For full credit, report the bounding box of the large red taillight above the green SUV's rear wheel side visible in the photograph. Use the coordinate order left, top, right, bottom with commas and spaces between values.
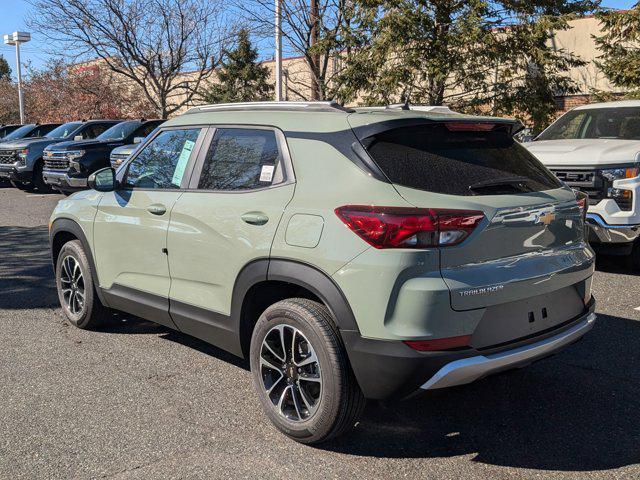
336, 205, 484, 248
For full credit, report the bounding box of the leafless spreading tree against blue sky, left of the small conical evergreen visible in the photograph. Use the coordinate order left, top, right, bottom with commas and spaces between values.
28, 0, 231, 118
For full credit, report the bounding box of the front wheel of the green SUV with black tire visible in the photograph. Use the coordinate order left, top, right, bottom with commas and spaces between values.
56, 240, 111, 329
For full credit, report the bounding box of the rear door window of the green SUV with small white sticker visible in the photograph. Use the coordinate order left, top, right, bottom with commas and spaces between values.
198, 128, 279, 190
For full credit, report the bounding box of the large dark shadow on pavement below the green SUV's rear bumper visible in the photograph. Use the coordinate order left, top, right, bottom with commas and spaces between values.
324, 314, 640, 471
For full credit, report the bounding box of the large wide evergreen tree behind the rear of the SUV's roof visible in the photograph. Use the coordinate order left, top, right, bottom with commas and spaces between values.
333, 0, 599, 129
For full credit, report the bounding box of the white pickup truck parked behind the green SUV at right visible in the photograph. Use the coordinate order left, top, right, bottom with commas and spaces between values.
523, 100, 640, 268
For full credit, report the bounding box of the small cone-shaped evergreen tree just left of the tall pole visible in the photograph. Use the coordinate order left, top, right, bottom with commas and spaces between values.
201, 29, 273, 103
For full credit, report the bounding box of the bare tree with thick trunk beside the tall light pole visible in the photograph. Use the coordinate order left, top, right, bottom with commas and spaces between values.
236, 0, 353, 100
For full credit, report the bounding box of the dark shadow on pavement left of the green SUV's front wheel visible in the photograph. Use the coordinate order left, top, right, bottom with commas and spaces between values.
0, 225, 58, 309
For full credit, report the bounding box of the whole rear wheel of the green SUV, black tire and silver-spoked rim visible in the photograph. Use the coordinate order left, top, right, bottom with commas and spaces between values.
250, 298, 365, 444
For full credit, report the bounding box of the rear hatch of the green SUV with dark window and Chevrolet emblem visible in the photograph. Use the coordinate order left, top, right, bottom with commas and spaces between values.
354, 120, 593, 316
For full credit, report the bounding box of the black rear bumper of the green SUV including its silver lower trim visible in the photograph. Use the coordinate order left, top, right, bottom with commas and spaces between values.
341, 298, 596, 400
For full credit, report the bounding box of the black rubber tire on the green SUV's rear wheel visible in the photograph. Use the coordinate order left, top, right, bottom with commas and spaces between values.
250, 298, 366, 444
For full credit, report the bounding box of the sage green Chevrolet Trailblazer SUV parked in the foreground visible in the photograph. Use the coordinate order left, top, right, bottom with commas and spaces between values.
50, 102, 595, 443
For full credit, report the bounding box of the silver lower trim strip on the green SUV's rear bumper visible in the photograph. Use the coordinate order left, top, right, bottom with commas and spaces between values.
420, 313, 596, 390
